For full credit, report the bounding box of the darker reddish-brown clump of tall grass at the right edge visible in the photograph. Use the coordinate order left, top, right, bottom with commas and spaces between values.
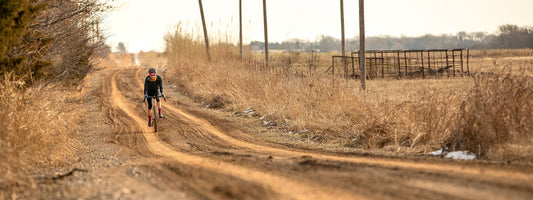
450, 70, 533, 159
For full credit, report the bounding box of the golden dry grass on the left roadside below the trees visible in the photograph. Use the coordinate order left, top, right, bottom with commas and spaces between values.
0, 75, 80, 191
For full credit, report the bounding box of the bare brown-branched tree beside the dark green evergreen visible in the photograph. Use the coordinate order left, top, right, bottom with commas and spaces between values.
30, 0, 113, 84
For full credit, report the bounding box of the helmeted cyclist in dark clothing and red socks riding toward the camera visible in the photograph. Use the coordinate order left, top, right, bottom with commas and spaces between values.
144, 68, 165, 127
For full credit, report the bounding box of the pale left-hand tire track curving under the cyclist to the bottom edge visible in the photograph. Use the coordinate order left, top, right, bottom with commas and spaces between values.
110, 67, 365, 199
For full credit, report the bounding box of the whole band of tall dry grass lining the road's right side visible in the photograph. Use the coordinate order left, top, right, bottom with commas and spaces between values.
162, 27, 533, 158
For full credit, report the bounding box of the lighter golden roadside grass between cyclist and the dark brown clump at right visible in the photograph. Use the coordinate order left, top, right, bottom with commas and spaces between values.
166, 57, 471, 148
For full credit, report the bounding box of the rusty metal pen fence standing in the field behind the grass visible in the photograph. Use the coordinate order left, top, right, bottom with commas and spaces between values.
327, 49, 470, 79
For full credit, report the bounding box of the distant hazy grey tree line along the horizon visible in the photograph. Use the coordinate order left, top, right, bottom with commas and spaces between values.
249, 24, 533, 52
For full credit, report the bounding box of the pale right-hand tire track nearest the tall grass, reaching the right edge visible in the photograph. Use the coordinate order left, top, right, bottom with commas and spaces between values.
131, 69, 533, 183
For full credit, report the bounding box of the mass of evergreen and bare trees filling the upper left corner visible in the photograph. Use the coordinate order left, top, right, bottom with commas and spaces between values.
0, 0, 113, 84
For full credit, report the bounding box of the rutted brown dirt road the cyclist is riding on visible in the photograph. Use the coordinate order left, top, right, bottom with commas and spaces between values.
11, 64, 533, 199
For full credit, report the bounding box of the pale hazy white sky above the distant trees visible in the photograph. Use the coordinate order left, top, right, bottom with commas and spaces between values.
104, 0, 533, 52
